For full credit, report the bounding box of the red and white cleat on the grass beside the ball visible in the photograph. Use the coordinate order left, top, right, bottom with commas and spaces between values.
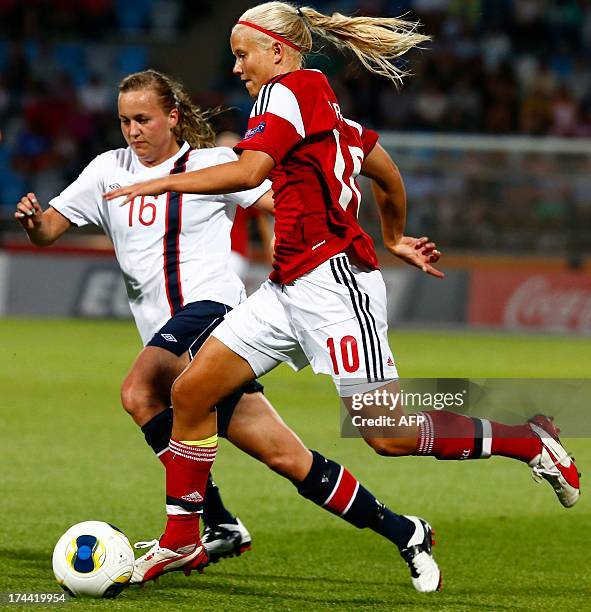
129, 540, 207, 584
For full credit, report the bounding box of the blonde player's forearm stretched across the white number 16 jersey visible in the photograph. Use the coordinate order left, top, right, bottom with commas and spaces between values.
103, 151, 275, 205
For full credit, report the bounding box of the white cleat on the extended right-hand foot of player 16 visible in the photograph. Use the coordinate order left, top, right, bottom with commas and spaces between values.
400, 516, 442, 593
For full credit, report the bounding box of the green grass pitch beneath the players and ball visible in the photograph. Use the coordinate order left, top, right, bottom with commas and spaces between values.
0, 320, 591, 612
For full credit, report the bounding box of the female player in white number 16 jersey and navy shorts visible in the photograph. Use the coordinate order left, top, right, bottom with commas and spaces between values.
15, 71, 454, 592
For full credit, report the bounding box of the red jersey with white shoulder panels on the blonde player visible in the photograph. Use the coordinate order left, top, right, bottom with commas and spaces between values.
235, 70, 378, 284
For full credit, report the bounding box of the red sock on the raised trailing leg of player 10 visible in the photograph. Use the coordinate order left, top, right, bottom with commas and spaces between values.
415, 410, 541, 462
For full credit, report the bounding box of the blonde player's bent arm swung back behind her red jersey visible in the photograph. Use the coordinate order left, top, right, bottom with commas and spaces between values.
361, 143, 444, 278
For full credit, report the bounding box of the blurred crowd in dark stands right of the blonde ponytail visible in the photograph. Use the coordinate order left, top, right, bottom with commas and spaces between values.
332, 0, 591, 137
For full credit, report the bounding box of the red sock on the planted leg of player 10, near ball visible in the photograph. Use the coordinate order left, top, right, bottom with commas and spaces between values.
160, 434, 217, 550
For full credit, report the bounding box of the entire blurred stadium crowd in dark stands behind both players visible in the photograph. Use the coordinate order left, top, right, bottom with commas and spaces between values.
0, 0, 591, 253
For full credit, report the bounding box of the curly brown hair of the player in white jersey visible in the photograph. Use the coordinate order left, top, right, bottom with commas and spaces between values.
119, 69, 217, 149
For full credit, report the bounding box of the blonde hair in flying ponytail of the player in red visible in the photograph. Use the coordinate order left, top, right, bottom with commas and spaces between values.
235, 2, 430, 85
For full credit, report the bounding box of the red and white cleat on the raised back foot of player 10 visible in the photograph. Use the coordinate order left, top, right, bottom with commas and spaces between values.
529, 414, 581, 508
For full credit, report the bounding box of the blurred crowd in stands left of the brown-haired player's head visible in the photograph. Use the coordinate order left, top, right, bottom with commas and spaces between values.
0, 0, 208, 210
